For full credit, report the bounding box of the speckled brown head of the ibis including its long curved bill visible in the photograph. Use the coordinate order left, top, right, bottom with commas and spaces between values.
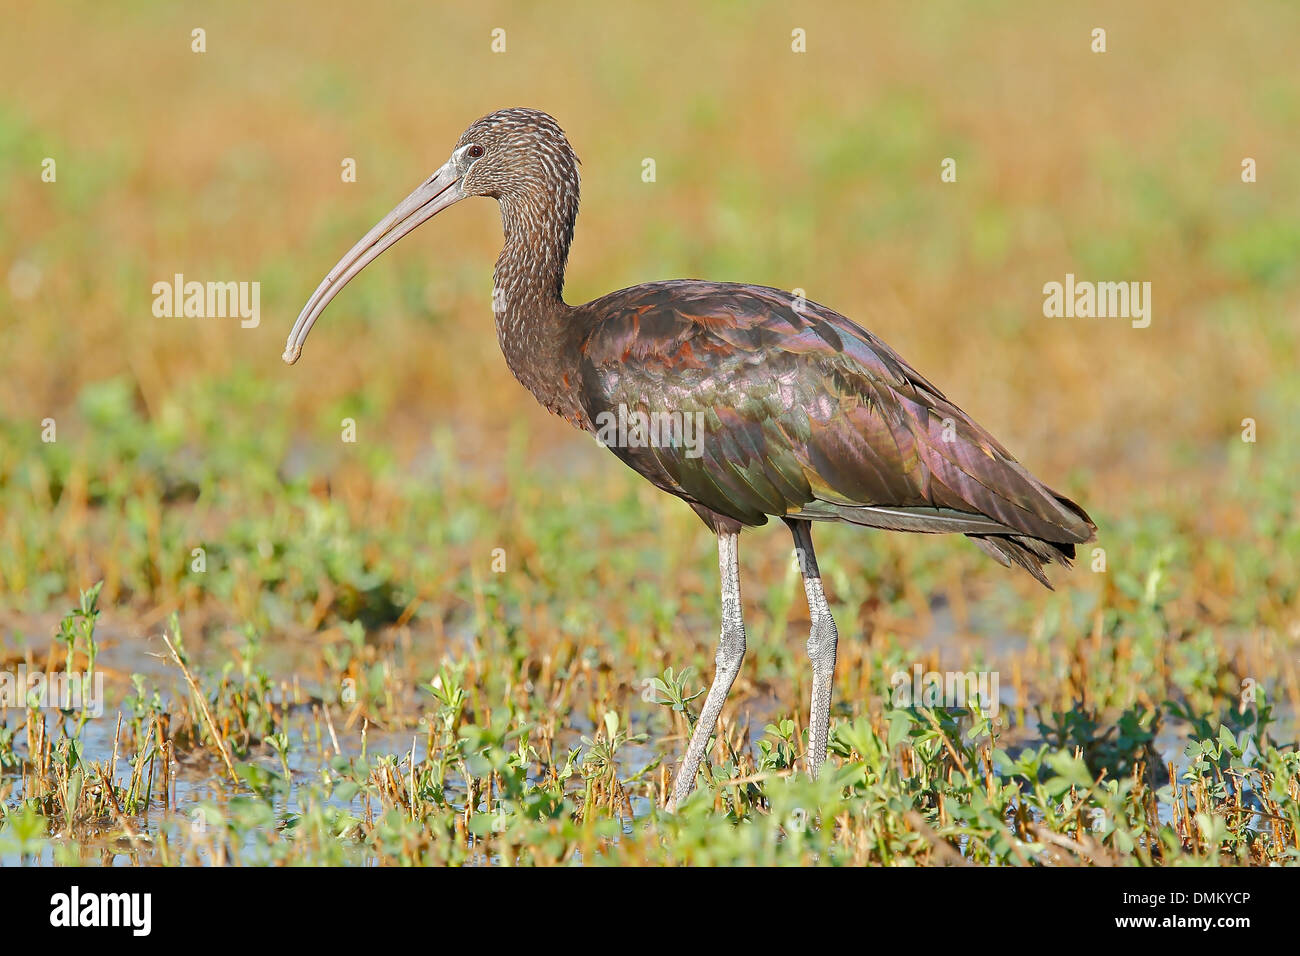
283, 109, 579, 365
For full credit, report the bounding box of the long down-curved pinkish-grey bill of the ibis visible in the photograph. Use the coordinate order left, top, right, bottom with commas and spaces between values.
282, 161, 464, 365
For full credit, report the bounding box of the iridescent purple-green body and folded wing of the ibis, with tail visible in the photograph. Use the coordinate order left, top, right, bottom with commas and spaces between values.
575, 280, 1095, 584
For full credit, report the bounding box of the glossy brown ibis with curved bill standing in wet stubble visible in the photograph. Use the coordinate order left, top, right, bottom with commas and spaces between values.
282, 108, 1096, 812
